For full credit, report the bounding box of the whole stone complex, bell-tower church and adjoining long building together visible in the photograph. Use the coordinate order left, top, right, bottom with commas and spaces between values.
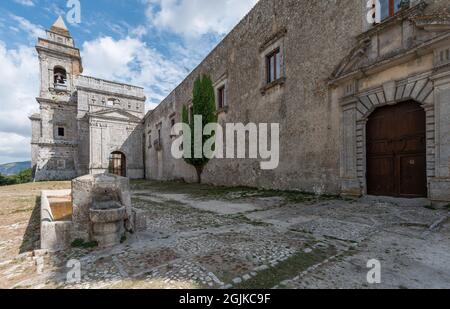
31, 0, 450, 202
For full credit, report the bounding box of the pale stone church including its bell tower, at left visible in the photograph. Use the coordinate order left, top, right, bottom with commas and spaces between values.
30, 17, 146, 180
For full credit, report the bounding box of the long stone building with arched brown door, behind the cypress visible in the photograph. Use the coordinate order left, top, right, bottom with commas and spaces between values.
144, 0, 450, 201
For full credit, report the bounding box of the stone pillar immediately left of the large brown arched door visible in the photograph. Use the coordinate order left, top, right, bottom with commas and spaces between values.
341, 97, 362, 197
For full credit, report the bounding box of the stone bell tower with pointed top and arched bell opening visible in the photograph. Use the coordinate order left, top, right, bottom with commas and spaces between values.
30, 17, 83, 181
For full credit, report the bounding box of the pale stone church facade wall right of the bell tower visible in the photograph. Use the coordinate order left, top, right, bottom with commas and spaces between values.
76, 76, 145, 179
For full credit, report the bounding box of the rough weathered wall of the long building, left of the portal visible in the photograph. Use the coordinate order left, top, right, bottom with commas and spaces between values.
145, 0, 448, 197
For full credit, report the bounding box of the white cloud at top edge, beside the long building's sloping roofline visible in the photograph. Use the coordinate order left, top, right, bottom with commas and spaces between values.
147, 0, 258, 37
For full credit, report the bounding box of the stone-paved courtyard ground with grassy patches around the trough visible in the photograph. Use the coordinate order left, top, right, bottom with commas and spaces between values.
0, 181, 450, 288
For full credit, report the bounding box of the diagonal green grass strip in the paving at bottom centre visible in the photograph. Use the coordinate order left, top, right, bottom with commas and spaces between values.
234, 247, 336, 289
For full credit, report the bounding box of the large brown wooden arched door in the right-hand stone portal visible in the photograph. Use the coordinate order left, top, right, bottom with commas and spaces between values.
366, 101, 427, 198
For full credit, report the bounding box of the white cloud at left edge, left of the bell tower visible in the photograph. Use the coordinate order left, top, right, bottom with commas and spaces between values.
0, 41, 39, 162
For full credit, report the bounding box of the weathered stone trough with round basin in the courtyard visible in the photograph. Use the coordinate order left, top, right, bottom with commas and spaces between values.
41, 174, 146, 250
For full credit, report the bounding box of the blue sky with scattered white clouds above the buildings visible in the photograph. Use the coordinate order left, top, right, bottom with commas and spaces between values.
0, 0, 258, 164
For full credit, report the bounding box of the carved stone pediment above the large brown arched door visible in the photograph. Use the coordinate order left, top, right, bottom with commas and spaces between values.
330, 1, 450, 83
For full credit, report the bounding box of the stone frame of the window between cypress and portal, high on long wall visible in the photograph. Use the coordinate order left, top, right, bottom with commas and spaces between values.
259, 28, 287, 95
